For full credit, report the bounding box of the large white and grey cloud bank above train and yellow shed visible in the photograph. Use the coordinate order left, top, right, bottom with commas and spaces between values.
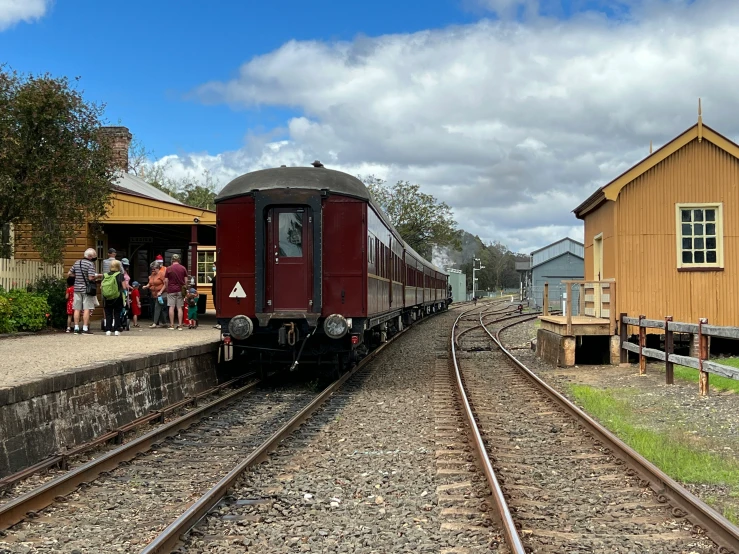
165, 0, 739, 251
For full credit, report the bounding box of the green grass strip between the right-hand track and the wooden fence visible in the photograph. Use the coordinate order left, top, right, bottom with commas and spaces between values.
569, 382, 739, 524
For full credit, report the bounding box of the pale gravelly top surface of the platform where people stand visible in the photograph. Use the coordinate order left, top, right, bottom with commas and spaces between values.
0, 314, 220, 389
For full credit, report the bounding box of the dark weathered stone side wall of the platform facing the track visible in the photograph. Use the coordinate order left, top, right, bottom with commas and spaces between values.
0, 343, 218, 477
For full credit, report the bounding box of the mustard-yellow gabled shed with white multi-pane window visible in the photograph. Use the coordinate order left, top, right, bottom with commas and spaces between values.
574, 114, 739, 326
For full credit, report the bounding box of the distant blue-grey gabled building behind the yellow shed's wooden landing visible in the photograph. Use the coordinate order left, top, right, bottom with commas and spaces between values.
530, 238, 585, 309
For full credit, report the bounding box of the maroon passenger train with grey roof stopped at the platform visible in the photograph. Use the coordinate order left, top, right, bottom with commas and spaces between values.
215, 162, 451, 370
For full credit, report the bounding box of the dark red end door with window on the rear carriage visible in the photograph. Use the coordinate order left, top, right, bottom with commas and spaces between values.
266, 208, 313, 312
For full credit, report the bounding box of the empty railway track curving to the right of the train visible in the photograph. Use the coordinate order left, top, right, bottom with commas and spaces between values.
451, 304, 739, 554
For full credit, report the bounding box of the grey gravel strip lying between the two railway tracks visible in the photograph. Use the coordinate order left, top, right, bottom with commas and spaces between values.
184, 312, 501, 553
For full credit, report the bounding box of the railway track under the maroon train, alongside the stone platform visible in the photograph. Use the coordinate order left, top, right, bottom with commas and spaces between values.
0, 302, 462, 553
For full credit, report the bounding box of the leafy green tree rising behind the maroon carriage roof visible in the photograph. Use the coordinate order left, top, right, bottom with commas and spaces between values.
359, 175, 461, 259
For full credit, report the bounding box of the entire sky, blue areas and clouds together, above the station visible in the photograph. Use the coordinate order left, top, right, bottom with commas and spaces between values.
0, 0, 739, 252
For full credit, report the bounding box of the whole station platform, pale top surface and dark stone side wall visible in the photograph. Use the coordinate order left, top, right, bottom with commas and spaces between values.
0, 314, 220, 478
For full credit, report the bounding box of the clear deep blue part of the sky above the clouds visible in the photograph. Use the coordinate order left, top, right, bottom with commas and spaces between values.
0, 0, 632, 157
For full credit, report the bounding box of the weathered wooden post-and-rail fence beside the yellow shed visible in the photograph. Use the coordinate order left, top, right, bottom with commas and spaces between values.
620, 314, 739, 396
